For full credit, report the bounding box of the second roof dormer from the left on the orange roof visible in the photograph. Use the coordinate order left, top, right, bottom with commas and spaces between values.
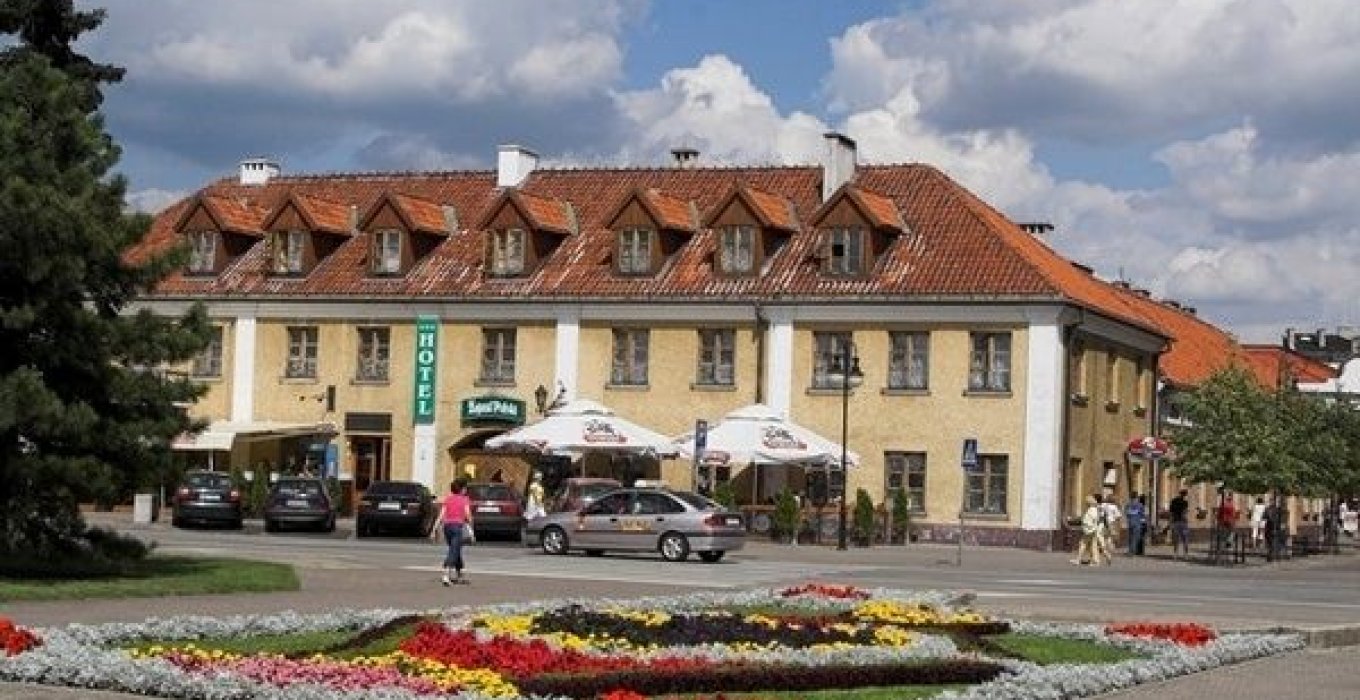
262, 194, 358, 277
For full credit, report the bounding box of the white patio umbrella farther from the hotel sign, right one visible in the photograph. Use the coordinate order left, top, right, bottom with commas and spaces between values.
675, 404, 860, 466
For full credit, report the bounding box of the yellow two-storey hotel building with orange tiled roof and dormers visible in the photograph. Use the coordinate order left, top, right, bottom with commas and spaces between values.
129, 133, 1232, 548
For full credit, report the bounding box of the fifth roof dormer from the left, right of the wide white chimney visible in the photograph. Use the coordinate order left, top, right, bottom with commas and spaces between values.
605, 189, 699, 277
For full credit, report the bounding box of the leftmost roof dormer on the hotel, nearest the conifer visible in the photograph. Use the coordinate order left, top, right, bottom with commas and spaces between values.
174, 194, 264, 276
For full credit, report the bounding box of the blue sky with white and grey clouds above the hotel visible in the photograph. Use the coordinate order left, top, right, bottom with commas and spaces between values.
80, 0, 1360, 343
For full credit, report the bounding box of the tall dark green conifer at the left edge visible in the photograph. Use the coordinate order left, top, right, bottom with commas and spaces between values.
0, 0, 208, 555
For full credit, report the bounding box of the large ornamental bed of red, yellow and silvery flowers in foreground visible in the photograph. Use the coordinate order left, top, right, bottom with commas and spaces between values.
0, 584, 1302, 700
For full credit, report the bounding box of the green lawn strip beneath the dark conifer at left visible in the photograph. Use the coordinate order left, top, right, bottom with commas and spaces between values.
0, 556, 301, 602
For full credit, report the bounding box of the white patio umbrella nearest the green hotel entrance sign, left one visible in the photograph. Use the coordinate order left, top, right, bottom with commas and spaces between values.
487, 398, 679, 457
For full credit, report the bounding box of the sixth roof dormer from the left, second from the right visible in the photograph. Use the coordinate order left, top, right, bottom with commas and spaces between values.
703, 186, 798, 277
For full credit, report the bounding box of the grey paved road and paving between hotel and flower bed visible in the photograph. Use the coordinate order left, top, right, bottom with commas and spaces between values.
0, 515, 1360, 700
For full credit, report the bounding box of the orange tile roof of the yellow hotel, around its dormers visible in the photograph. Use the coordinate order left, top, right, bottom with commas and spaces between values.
138, 164, 1272, 369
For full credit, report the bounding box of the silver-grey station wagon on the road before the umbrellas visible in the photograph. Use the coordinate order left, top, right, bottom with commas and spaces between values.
525, 488, 747, 564
